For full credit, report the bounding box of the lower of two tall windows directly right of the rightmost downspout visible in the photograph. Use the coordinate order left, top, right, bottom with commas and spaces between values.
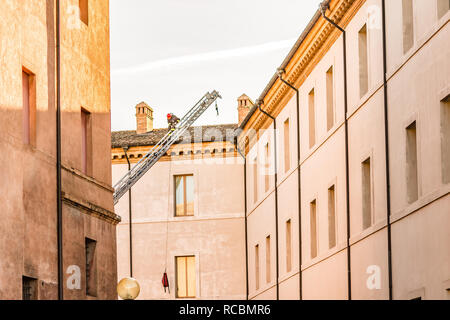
406, 121, 419, 203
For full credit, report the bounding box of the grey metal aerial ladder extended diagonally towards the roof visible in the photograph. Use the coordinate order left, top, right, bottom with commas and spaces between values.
114, 90, 222, 204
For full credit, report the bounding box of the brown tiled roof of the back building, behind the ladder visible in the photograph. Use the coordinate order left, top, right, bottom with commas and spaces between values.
111, 124, 238, 148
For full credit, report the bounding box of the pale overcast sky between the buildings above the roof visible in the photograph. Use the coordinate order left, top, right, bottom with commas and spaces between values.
110, 0, 320, 131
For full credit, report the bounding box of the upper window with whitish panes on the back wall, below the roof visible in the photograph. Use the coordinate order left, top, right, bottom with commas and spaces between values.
175, 175, 194, 217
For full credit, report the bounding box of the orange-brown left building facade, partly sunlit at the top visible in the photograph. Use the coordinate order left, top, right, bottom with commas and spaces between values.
0, 0, 120, 300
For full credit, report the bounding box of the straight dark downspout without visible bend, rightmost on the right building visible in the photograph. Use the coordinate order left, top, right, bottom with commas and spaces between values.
381, 0, 393, 300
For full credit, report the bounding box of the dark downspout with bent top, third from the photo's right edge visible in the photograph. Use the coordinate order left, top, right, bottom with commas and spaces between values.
278, 68, 303, 300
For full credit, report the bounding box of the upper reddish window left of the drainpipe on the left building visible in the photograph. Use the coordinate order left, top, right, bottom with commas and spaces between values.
22, 70, 36, 145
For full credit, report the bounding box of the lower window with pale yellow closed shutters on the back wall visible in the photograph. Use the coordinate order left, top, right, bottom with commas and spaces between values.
176, 256, 196, 298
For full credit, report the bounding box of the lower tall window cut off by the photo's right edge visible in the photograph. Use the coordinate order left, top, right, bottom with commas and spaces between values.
441, 97, 450, 184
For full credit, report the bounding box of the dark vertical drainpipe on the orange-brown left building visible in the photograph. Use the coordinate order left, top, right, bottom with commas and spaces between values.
56, 0, 64, 300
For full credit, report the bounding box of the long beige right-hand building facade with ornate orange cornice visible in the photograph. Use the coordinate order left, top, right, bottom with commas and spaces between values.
239, 0, 450, 300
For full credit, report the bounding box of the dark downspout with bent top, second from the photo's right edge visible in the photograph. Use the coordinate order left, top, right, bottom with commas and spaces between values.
320, 0, 352, 300
